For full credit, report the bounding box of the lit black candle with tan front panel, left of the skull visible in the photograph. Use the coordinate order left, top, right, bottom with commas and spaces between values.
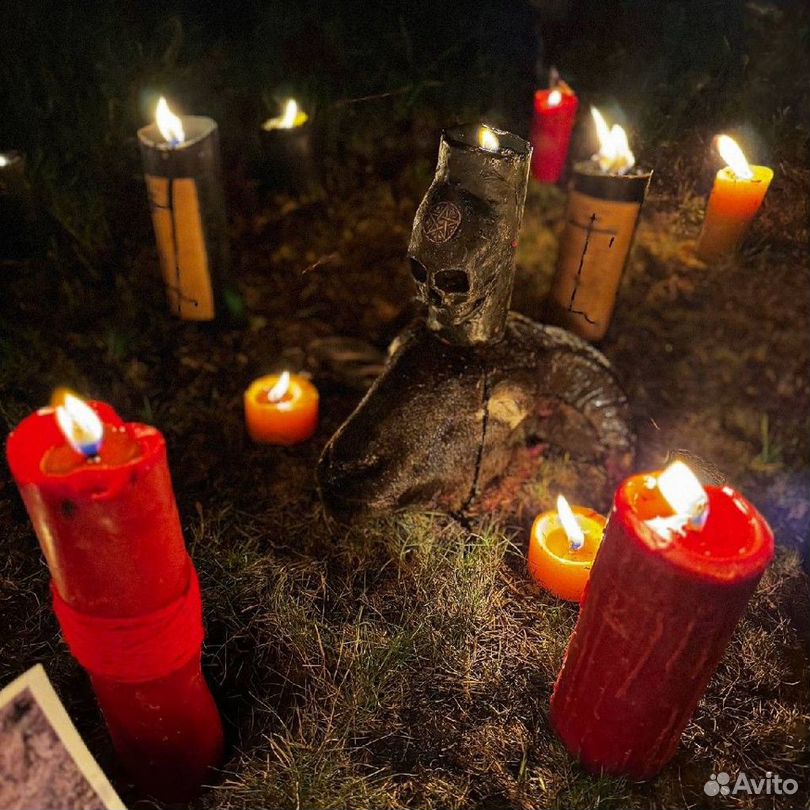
138, 99, 229, 321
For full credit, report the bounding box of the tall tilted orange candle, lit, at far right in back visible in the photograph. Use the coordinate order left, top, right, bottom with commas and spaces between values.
697, 135, 773, 261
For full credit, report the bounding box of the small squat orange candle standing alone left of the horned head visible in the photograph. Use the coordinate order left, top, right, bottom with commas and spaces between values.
245, 371, 318, 445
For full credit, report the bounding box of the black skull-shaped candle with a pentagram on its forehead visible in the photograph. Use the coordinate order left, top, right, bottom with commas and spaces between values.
408, 125, 531, 345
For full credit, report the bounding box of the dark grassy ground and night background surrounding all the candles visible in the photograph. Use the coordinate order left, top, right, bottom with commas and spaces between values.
0, 0, 810, 810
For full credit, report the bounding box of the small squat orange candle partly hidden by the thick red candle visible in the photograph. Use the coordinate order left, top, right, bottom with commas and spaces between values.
529, 495, 605, 602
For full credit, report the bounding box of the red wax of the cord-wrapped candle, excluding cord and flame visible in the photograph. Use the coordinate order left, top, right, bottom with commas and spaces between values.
7, 402, 222, 801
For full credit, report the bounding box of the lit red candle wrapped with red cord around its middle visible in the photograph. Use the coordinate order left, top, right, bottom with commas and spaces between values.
7, 390, 223, 801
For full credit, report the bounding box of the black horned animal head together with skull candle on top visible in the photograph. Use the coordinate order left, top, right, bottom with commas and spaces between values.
318, 127, 634, 517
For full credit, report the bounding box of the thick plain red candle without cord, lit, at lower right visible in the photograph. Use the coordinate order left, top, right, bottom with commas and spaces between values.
551, 462, 773, 779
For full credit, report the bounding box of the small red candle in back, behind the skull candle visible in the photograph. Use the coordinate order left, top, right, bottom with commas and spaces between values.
531, 83, 579, 183
